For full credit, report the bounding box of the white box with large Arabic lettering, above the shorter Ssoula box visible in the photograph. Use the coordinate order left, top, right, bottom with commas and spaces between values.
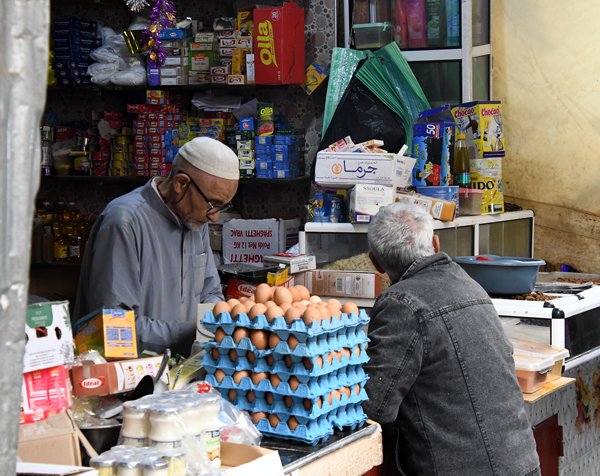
315, 151, 396, 188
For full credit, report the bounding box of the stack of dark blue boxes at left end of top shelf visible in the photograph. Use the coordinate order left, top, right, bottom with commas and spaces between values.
52, 18, 101, 86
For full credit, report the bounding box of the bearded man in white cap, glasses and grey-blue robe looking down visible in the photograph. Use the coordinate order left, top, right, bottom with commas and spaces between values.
75, 137, 239, 355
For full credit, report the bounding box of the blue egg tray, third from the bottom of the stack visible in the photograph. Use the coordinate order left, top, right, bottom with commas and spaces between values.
206, 366, 367, 398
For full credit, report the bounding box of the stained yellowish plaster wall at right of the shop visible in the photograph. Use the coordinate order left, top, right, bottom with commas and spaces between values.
492, 0, 600, 273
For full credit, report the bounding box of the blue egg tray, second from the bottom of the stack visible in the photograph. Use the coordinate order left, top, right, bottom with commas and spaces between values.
219, 380, 369, 424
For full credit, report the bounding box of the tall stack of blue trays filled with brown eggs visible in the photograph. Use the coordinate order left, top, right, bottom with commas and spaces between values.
203, 284, 369, 444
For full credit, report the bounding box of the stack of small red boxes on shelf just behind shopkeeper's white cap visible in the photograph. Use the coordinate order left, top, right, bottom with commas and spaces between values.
127, 90, 184, 176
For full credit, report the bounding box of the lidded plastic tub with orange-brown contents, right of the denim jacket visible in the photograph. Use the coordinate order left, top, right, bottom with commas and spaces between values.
510, 338, 569, 393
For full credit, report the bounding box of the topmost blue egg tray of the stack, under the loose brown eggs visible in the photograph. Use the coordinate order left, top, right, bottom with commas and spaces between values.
203, 309, 369, 340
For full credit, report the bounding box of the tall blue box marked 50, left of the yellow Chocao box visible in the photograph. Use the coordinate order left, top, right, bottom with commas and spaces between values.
412, 106, 455, 186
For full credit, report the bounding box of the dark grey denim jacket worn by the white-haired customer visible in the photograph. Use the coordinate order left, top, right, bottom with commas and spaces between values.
364, 253, 539, 476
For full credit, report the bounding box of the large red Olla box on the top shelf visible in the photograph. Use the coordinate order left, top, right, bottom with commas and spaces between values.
253, 2, 305, 84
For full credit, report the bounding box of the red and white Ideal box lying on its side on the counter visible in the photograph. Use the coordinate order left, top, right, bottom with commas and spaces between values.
70, 356, 168, 397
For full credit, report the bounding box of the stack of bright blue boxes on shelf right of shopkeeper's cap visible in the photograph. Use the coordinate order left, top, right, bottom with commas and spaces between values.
254, 134, 303, 179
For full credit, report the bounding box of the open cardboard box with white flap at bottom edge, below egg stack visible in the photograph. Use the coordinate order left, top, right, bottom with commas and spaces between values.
221, 442, 284, 476
